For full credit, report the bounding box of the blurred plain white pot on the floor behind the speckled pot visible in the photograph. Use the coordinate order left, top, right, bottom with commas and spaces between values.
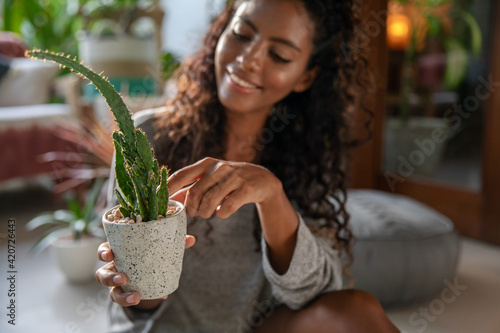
51, 236, 103, 283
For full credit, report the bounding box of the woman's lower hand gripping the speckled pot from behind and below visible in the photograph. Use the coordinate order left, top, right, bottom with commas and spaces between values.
95, 235, 196, 310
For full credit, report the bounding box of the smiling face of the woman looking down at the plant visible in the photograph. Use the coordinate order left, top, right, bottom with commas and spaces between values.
215, 0, 317, 115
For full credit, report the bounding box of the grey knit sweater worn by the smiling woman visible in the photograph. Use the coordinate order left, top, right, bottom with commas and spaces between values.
109, 112, 342, 333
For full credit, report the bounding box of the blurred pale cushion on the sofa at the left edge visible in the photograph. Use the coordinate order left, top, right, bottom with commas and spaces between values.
0, 58, 58, 106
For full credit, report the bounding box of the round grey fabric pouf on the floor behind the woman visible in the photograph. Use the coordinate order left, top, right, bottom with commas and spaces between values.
346, 190, 460, 308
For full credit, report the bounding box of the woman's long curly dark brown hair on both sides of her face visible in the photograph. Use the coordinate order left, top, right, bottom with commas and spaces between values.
154, 0, 372, 278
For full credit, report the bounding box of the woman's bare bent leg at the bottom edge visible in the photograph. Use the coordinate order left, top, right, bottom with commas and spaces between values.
254, 290, 399, 333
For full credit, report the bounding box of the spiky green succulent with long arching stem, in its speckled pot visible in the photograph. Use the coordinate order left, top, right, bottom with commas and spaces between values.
27, 49, 187, 299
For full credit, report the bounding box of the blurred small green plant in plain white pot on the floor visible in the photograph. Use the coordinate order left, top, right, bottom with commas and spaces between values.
26, 178, 104, 283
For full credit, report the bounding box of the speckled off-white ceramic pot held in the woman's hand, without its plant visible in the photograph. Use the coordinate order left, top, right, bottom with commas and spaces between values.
102, 200, 187, 299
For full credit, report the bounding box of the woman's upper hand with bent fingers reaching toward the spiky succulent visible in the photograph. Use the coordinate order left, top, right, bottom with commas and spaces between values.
168, 157, 283, 219
